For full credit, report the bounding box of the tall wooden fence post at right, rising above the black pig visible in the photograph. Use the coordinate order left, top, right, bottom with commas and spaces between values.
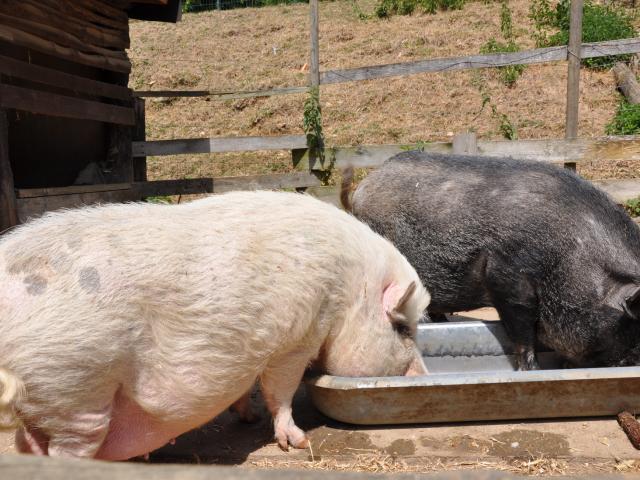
565, 0, 583, 140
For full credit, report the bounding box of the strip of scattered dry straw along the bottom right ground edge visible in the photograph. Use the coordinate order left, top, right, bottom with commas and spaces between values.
247, 455, 640, 477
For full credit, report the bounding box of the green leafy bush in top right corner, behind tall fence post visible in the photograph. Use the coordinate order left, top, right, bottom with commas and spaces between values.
529, 0, 636, 69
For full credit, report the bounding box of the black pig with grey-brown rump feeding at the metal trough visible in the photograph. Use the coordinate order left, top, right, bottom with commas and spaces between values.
341, 152, 640, 370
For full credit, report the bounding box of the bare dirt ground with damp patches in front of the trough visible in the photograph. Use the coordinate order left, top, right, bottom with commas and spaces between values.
5, 382, 640, 475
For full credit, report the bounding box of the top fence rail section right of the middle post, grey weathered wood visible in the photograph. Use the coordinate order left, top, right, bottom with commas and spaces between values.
320, 38, 640, 85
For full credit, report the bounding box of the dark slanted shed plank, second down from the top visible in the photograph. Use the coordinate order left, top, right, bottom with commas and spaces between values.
0, 24, 131, 73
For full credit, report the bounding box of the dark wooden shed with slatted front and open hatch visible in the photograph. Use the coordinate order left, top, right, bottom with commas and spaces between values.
0, 0, 181, 231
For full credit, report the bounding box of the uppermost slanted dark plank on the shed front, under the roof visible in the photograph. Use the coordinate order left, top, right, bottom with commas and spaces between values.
0, 0, 130, 50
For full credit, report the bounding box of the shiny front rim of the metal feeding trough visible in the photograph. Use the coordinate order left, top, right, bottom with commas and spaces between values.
305, 367, 640, 390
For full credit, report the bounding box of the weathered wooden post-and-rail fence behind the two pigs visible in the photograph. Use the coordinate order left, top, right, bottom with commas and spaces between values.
13, 0, 640, 220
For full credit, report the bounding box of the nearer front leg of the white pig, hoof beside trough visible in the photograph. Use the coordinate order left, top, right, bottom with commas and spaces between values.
260, 350, 310, 451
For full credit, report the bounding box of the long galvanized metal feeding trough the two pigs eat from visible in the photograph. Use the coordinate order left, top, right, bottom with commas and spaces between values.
306, 321, 640, 425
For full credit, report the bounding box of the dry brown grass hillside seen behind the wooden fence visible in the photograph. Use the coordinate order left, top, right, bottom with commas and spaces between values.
130, 0, 640, 182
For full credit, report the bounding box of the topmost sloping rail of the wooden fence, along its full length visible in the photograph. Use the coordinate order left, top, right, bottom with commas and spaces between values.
134, 38, 640, 100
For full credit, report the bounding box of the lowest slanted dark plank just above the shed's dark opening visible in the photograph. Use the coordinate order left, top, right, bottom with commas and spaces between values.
0, 85, 135, 125
